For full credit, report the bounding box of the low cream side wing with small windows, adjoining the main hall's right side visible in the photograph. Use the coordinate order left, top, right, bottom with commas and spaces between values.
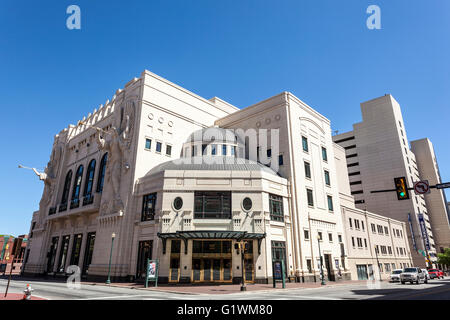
334, 144, 413, 280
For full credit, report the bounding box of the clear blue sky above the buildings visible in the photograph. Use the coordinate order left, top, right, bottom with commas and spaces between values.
0, 0, 450, 235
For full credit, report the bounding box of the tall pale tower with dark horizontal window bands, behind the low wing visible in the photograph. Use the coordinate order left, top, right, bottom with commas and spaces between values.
333, 95, 436, 267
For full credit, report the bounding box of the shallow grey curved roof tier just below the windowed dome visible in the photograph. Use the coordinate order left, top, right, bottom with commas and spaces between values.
146, 156, 279, 176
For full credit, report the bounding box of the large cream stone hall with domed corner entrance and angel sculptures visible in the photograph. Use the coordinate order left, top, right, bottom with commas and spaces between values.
25, 71, 416, 283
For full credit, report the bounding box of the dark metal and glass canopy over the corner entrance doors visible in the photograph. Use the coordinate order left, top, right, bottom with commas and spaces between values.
157, 230, 266, 254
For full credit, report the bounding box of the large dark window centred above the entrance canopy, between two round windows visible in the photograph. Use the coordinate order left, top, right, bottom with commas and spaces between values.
194, 191, 231, 219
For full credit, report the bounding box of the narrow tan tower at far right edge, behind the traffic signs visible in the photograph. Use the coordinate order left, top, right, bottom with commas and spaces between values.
411, 138, 450, 252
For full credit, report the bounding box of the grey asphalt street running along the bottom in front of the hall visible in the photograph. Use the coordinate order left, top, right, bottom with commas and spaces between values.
0, 278, 450, 300
